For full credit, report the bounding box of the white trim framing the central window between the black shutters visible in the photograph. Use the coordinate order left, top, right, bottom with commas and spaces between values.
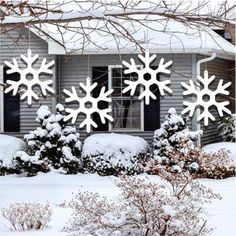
108, 65, 144, 132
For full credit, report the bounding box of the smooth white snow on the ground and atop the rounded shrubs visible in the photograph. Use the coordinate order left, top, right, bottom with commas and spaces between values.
0, 137, 236, 236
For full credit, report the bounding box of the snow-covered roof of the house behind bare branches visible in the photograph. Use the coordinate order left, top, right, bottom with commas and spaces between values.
0, 4, 236, 60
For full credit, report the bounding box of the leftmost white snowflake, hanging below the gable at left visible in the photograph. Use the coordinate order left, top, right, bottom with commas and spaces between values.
5, 49, 54, 105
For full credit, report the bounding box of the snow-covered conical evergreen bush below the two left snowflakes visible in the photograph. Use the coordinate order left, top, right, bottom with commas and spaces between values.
13, 104, 81, 176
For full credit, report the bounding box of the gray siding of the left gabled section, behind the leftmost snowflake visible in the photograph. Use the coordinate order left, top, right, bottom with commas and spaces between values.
0, 29, 54, 137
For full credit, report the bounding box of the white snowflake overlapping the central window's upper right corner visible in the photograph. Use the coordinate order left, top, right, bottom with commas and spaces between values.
122, 50, 172, 105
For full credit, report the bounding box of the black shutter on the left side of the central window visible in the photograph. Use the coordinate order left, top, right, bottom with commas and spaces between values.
92, 67, 109, 131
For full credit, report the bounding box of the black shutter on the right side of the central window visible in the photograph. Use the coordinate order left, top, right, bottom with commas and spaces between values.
144, 67, 160, 131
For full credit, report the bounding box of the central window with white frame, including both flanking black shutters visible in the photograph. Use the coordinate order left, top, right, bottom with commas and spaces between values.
92, 66, 160, 132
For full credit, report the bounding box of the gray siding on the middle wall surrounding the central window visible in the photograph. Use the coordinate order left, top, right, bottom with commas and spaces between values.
58, 54, 192, 142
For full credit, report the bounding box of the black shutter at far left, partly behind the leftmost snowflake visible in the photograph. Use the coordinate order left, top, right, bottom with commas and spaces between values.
3, 67, 20, 132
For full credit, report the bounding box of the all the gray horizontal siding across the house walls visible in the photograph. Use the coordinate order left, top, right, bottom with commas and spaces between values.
0, 26, 231, 145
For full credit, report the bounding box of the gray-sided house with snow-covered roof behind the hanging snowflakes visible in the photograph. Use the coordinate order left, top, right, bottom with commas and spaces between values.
0, 12, 235, 144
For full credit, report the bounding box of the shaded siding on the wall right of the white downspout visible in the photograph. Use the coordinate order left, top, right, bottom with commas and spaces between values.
199, 58, 232, 146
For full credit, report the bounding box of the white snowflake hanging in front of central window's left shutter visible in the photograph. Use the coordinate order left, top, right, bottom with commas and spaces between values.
63, 77, 113, 133
